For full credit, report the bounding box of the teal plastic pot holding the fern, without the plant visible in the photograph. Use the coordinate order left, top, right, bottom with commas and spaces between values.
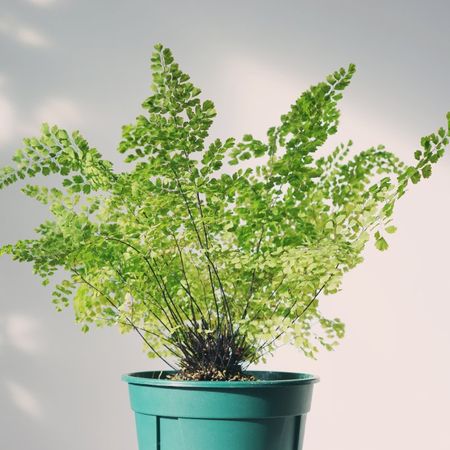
122, 371, 319, 450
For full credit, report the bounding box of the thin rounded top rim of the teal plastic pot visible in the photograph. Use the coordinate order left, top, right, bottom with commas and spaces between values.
122, 370, 320, 389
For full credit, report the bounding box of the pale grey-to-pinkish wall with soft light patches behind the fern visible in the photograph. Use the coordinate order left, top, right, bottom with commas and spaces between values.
0, 0, 450, 450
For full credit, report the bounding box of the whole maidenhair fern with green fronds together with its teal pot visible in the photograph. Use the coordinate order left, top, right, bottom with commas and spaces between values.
0, 45, 450, 450
